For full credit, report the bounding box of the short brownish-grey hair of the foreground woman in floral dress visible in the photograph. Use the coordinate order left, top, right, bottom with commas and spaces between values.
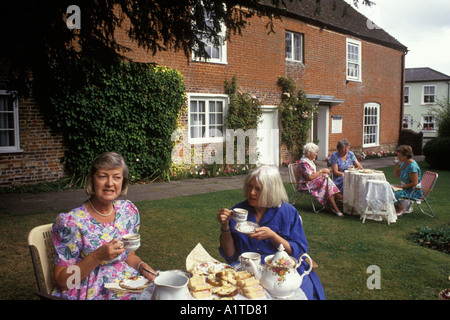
84, 152, 129, 196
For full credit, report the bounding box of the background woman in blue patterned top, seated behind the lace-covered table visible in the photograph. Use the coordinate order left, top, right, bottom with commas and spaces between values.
328, 139, 363, 193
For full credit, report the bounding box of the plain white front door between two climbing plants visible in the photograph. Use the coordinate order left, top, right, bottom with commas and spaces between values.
257, 106, 280, 166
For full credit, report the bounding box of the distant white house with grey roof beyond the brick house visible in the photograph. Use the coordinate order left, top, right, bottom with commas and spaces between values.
403, 68, 450, 140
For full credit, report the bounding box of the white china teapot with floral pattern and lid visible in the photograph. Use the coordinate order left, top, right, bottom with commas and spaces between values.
249, 244, 313, 299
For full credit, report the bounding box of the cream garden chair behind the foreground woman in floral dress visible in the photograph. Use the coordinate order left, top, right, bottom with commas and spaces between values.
28, 223, 64, 300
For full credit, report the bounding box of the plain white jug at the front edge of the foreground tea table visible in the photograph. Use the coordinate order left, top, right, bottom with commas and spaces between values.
151, 271, 191, 300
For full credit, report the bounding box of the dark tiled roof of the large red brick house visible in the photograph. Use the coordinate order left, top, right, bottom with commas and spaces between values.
262, 0, 407, 52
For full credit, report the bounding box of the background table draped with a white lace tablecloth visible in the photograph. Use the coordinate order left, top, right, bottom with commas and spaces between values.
343, 170, 397, 223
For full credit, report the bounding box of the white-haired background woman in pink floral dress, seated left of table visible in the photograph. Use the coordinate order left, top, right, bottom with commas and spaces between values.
297, 142, 344, 217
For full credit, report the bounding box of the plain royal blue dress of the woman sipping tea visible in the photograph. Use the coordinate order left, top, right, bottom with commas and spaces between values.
219, 200, 325, 300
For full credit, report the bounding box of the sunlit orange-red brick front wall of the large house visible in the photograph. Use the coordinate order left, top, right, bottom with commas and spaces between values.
120, 14, 403, 161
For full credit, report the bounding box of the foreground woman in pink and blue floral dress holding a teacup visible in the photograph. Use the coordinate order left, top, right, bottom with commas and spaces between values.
52, 152, 158, 300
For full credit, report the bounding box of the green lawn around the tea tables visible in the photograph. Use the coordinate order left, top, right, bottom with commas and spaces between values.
0, 163, 450, 300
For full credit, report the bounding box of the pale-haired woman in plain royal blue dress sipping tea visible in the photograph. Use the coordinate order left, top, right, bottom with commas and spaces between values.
217, 166, 325, 300
